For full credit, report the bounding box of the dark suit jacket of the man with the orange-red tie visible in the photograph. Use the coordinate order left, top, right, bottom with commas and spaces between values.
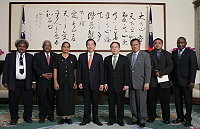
77, 52, 104, 90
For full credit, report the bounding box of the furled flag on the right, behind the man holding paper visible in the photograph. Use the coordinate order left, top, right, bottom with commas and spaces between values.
148, 7, 153, 51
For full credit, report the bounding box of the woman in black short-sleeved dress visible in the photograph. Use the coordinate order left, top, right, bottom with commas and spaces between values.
53, 42, 77, 124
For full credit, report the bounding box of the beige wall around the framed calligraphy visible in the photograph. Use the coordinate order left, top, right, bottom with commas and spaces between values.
0, 0, 194, 60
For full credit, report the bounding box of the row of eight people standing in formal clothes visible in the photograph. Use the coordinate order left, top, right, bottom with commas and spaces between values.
2, 37, 197, 127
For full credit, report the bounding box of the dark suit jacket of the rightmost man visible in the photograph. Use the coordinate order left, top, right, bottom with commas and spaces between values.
172, 48, 198, 86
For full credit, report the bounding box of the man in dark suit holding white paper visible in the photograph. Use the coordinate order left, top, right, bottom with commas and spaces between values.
147, 38, 173, 124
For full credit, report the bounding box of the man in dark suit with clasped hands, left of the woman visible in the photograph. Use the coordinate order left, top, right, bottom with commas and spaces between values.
33, 40, 55, 123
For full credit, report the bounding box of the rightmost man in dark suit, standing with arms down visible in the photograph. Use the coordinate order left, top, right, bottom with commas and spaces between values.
172, 37, 197, 127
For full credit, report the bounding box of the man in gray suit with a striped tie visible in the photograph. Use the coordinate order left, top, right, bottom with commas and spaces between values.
127, 39, 151, 127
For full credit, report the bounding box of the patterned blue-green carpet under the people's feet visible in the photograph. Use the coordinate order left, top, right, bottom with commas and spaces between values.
0, 104, 200, 129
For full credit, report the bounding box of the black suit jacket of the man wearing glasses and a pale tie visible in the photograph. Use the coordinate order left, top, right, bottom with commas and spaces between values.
104, 54, 130, 92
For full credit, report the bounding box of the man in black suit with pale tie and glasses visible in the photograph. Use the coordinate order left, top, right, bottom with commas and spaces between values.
104, 42, 130, 126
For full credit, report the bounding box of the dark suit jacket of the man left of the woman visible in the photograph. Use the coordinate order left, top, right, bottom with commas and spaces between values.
33, 52, 56, 85
